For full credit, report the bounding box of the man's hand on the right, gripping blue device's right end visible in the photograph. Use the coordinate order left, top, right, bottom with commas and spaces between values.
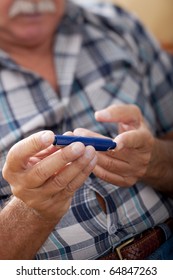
74, 105, 154, 187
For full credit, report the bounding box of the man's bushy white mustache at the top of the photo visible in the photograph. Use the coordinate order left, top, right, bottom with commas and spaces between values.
9, 0, 56, 18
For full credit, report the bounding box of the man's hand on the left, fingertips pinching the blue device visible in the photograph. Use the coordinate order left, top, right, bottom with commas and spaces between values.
3, 131, 97, 222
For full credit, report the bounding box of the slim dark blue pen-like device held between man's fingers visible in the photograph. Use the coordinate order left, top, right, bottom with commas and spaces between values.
53, 135, 116, 151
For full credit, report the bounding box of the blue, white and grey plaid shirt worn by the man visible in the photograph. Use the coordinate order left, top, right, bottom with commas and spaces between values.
0, 0, 173, 259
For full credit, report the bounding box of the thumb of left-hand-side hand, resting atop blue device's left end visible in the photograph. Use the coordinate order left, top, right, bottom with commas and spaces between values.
4, 131, 54, 172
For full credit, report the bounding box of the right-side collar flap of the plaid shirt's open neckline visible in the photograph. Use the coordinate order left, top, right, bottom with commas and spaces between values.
54, 1, 83, 97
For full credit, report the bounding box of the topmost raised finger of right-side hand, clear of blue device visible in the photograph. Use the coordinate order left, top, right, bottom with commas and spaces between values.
95, 104, 142, 127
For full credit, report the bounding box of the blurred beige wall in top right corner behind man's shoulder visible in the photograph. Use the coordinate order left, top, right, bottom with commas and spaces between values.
105, 0, 173, 50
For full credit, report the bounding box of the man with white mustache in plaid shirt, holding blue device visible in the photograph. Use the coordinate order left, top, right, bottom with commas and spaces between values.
0, 0, 173, 260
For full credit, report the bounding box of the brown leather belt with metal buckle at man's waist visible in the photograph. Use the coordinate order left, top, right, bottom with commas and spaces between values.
99, 218, 173, 260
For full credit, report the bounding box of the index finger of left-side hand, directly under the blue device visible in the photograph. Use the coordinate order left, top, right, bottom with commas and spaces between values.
26, 142, 85, 187
